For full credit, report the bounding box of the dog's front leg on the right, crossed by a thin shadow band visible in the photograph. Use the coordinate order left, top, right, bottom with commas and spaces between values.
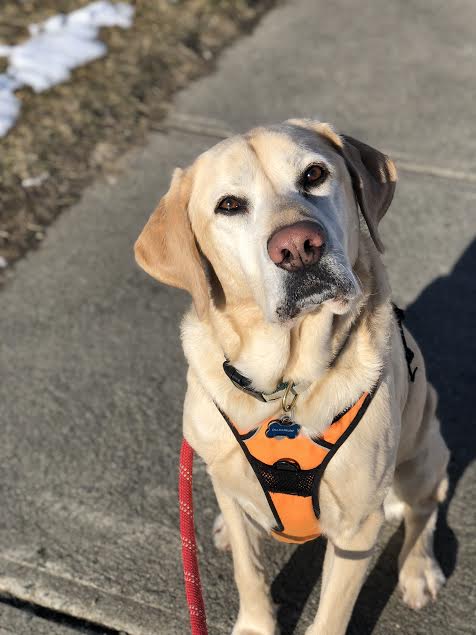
306, 511, 383, 635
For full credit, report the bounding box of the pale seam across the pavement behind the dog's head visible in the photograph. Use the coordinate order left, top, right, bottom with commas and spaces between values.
164, 113, 476, 185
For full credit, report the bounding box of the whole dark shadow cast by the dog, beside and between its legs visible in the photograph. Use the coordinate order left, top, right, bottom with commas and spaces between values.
271, 240, 476, 635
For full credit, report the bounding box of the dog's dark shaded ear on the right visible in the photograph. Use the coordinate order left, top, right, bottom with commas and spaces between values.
340, 135, 397, 253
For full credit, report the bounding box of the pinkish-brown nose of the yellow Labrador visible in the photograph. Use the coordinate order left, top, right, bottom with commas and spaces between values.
268, 221, 324, 271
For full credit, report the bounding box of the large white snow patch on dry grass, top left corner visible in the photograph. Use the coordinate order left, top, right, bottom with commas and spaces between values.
0, 0, 134, 137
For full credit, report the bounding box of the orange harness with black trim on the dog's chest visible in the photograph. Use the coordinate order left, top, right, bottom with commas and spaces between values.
219, 390, 375, 543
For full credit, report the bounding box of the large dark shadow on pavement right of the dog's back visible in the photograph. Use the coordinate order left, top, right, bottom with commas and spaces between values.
407, 240, 476, 576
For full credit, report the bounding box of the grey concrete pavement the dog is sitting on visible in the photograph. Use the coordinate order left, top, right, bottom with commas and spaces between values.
0, 0, 476, 635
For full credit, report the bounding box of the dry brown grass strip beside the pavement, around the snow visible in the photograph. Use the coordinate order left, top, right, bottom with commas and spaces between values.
0, 0, 273, 270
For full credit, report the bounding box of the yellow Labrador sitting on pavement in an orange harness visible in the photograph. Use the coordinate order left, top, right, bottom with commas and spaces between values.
135, 119, 449, 635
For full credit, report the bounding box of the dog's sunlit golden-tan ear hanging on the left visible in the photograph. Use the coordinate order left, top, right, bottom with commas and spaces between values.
134, 168, 209, 319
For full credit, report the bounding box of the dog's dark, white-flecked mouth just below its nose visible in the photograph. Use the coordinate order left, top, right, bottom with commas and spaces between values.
276, 256, 358, 322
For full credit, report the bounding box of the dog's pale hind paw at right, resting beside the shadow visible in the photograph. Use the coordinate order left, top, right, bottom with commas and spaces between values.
399, 556, 446, 610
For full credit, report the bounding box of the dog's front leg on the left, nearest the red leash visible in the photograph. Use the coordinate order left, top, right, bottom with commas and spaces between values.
213, 480, 275, 635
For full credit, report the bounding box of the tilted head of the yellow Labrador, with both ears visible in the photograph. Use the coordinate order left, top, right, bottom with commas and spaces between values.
135, 120, 396, 322
